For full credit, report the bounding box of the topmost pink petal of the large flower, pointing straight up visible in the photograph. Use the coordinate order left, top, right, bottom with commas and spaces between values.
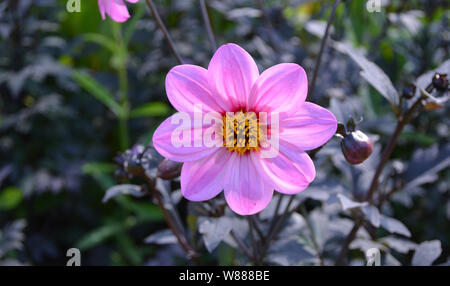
208, 44, 259, 112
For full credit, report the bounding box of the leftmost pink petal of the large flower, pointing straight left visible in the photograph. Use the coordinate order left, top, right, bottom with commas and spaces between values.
152, 113, 219, 162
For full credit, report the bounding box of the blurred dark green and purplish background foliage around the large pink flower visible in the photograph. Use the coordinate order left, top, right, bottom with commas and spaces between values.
0, 0, 450, 265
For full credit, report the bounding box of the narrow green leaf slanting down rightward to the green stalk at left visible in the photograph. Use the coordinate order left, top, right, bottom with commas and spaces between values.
72, 71, 123, 117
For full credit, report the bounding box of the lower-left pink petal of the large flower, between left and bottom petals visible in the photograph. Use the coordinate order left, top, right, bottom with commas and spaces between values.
181, 148, 235, 201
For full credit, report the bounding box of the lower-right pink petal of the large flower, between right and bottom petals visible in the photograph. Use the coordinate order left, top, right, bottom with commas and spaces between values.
253, 145, 316, 194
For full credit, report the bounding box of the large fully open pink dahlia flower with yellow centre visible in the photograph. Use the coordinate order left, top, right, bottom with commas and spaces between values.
153, 44, 337, 215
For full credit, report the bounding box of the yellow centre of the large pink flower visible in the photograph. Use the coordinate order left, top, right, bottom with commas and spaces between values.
223, 111, 259, 155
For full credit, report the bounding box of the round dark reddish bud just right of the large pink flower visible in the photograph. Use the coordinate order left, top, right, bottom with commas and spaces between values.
341, 130, 373, 165
